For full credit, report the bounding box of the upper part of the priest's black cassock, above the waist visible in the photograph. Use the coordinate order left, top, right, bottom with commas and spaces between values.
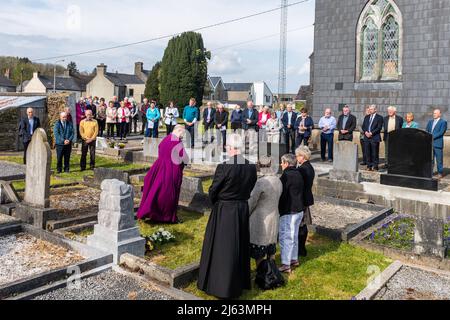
209, 156, 258, 205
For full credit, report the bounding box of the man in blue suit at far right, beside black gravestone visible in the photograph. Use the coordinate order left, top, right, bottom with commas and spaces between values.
427, 109, 448, 179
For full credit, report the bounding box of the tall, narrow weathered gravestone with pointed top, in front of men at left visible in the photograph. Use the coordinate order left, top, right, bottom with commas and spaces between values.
14, 128, 57, 229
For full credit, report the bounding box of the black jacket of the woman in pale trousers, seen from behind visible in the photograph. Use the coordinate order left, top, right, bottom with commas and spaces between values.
278, 167, 305, 216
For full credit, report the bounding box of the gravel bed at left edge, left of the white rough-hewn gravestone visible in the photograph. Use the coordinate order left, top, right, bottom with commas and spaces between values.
0, 233, 85, 285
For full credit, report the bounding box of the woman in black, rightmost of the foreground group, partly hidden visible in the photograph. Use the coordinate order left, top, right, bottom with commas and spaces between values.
295, 146, 316, 257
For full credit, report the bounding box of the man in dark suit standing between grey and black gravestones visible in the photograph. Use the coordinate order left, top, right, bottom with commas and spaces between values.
362, 105, 383, 171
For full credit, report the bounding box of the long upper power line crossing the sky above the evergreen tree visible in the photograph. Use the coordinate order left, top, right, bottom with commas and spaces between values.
32, 0, 310, 62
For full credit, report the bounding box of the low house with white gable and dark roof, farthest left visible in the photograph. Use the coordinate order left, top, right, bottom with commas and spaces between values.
22, 71, 92, 99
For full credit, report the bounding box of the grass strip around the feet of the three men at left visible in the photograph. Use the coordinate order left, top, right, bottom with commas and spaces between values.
0, 153, 148, 186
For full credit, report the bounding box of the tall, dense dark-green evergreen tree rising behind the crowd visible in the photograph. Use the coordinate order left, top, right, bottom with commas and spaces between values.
160, 32, 211, 107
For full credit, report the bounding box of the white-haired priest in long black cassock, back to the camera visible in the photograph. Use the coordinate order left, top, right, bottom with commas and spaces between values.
197, 134, 257, 299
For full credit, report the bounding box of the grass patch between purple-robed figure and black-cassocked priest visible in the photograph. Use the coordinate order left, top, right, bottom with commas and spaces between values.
138, 211, 208, 269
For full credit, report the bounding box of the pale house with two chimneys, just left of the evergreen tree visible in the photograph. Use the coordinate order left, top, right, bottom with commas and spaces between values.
86, 63, 149, 103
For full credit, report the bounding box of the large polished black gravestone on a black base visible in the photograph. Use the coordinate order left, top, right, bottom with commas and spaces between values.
381, 129, 438, 191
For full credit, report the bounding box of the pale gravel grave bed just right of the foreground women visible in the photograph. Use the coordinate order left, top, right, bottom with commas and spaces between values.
311, 201, 376, 230
